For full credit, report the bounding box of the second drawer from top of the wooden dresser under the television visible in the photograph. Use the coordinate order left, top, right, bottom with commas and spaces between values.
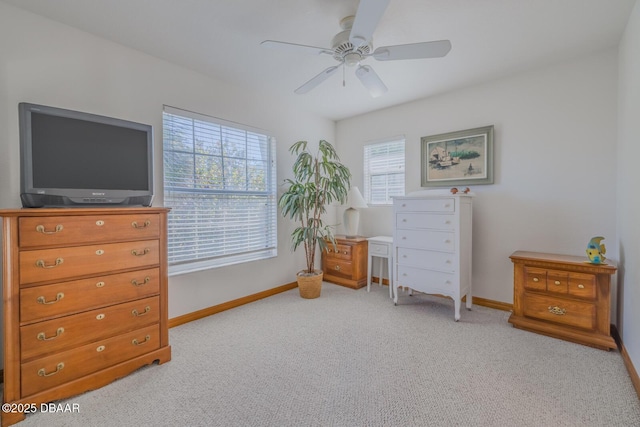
20, 240, 160, 284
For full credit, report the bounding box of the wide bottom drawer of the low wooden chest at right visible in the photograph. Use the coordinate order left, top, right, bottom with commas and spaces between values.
524, 293, 596, 330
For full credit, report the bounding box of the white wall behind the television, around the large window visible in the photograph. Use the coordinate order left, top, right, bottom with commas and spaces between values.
0, 2, 335, 366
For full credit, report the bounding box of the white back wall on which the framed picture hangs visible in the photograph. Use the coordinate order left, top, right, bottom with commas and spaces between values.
337, 49, 617, 303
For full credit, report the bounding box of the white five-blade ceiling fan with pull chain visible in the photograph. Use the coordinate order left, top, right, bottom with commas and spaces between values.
261, 0, 451, 98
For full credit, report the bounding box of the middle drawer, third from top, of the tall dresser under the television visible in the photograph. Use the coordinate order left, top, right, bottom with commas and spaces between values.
20, 268, 160, 325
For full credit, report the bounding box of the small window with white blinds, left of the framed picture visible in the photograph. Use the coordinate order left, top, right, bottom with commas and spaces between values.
364, 137, 404, 205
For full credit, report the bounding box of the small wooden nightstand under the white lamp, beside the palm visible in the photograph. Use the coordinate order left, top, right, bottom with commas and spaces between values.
322, 236, 368, 289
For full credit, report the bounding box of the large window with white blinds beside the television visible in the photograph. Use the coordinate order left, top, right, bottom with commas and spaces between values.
162, 106, 277, 274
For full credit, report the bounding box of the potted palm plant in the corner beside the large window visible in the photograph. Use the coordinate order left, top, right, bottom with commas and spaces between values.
278, 140, 351, 298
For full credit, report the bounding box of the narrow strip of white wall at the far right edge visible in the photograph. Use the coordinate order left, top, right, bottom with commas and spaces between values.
617, 2, 640, 380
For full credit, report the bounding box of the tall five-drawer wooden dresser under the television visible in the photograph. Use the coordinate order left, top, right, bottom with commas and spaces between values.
0, 208, 171, 426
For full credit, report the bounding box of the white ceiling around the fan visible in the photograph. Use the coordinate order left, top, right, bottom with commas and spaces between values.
2, 0, 636, 120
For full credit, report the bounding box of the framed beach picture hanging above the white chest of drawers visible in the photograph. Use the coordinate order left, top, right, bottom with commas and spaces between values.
420, 125, 493, 187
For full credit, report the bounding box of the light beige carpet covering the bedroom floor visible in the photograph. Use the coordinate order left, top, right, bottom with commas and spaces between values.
15, 283, 640, 427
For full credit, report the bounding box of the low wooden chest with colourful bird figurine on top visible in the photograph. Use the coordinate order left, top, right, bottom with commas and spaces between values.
509, 251, 617, 350
